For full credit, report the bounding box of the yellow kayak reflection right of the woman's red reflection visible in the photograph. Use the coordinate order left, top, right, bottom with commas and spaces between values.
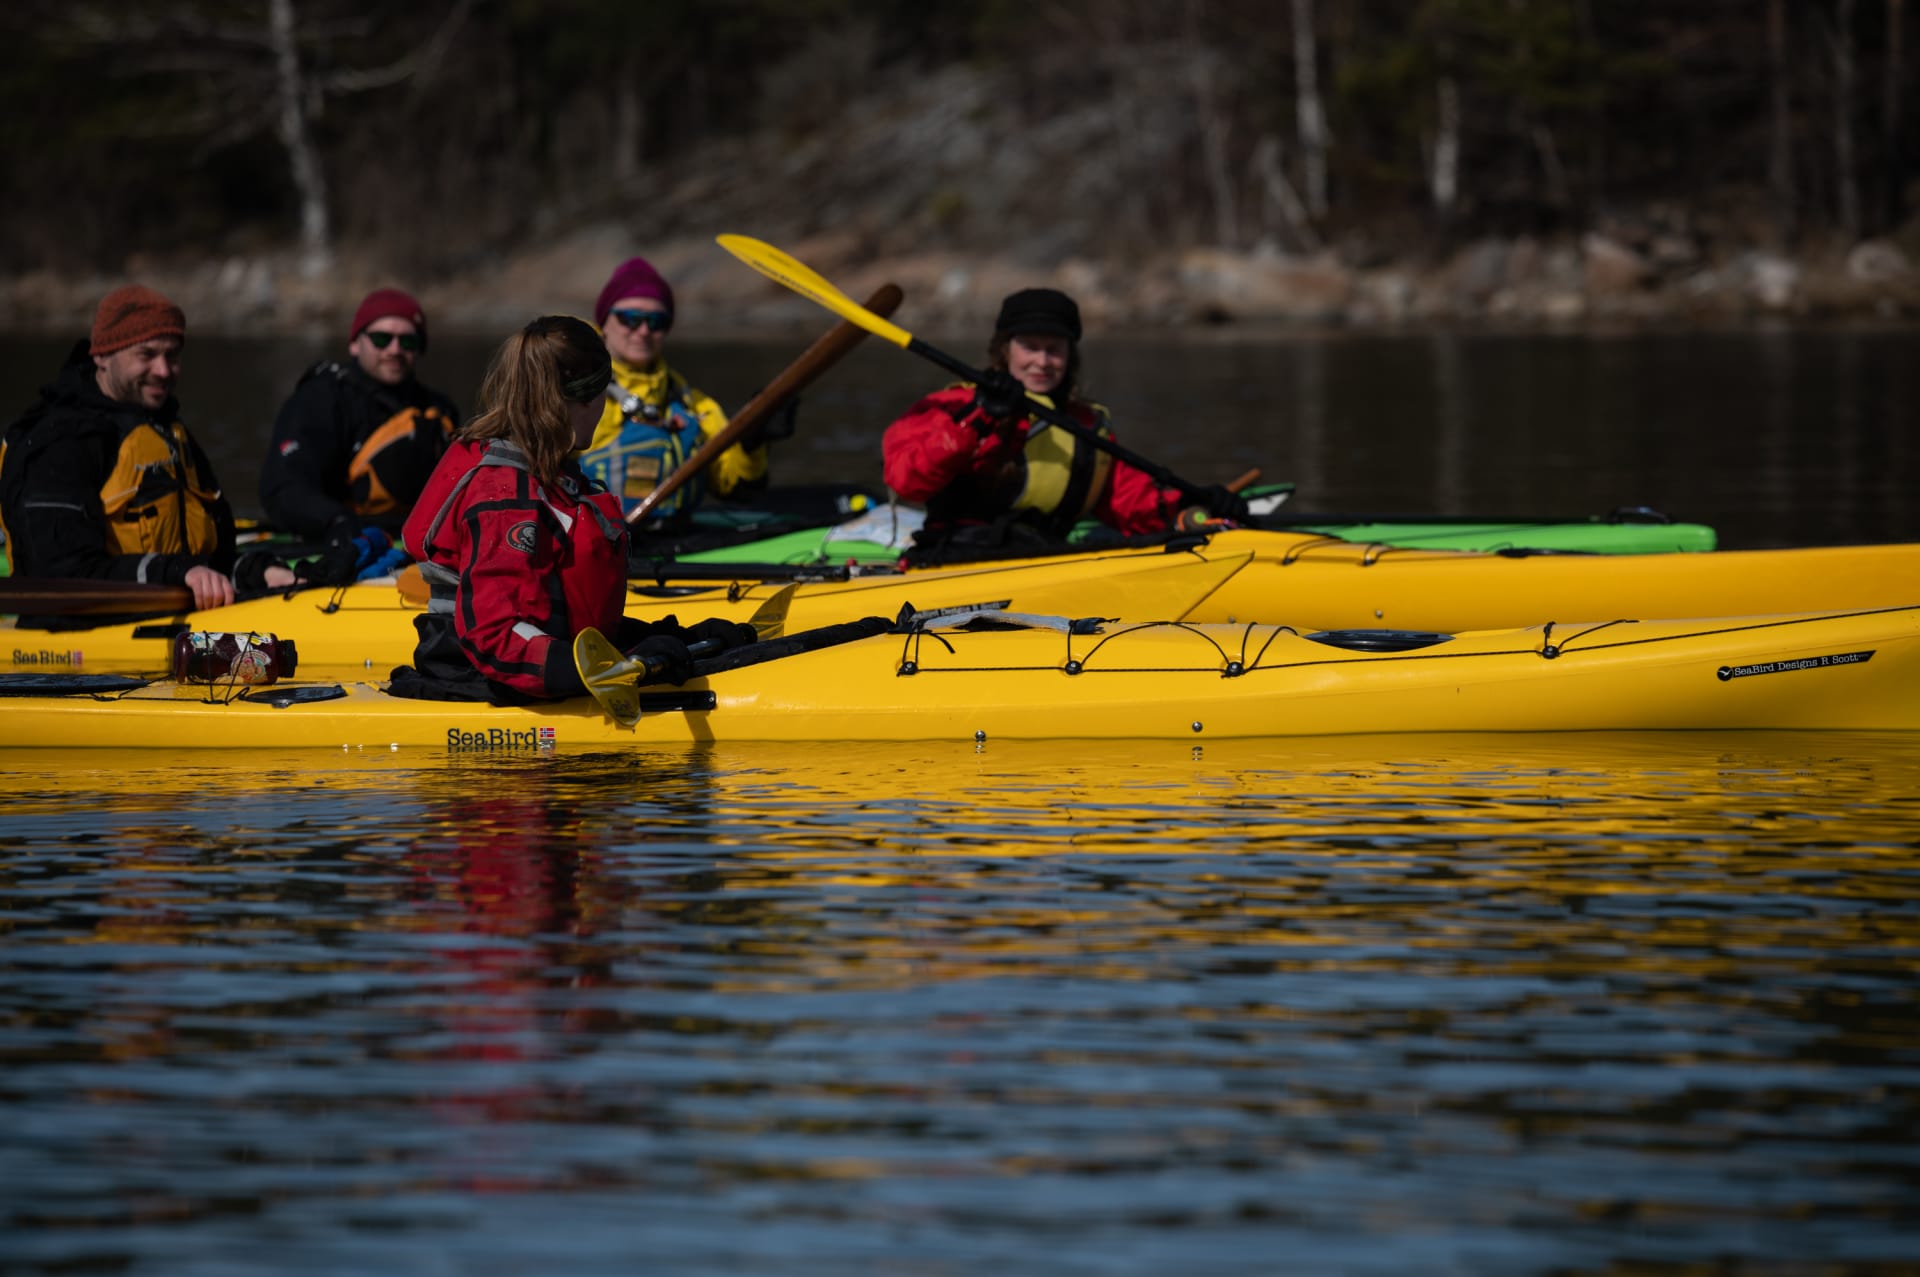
648, 734, 1920, 989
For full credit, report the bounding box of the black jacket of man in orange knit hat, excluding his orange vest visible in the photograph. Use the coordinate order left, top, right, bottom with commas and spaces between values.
0, 342, 234, 586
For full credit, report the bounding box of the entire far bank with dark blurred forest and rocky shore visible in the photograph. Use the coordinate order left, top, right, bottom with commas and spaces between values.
0, 0, 1920, 328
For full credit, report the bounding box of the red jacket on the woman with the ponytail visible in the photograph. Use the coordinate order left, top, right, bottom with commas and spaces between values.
396, 440, 626, 703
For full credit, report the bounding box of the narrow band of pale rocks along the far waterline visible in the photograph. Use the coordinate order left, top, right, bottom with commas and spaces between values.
0, 225, 1920, 336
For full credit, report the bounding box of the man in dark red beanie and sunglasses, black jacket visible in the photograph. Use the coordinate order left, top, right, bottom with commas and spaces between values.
259, 288, 459, 582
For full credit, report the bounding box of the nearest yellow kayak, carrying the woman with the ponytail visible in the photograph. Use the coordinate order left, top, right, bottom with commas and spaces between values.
0, 607, 1920, 753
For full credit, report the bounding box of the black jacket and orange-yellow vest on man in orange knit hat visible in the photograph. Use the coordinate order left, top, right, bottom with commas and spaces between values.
0, 342, 234, 586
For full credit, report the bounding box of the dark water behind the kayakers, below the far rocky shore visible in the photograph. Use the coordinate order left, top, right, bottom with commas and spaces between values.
0, 328, 1920, 547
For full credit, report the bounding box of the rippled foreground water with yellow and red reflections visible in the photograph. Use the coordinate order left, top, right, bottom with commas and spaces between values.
0, 734, 1920, 1275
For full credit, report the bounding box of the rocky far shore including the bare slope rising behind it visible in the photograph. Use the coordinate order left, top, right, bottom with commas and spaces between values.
0, 50, 1920, 336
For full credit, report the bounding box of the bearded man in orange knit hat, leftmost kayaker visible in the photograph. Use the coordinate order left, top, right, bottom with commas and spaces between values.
0, 284, 296, 624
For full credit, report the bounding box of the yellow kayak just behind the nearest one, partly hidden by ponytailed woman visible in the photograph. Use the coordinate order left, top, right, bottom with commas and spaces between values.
0, 530, 1920, 676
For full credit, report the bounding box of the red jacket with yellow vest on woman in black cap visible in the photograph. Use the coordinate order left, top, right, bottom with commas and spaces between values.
881, 384, 1171, 538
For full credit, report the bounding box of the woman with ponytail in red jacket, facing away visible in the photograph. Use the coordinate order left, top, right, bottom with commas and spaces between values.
392, 315, 753, 703
